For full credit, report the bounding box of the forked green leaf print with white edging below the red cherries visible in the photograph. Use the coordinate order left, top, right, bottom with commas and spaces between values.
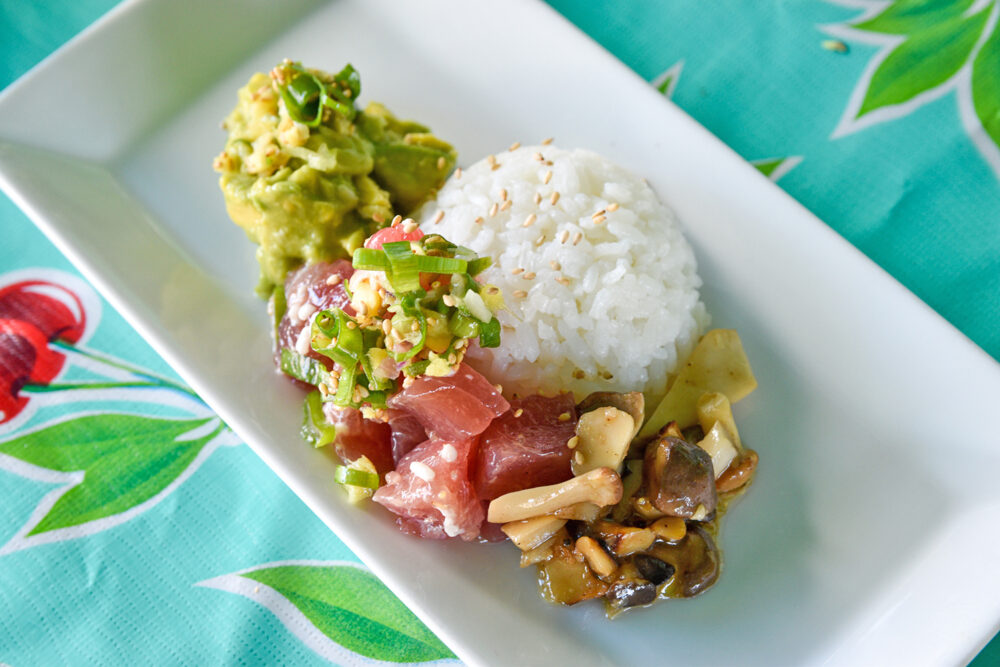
0, 413, 226, 554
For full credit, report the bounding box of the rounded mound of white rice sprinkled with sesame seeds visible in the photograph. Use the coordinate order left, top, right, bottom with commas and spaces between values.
420, 146, 708, 402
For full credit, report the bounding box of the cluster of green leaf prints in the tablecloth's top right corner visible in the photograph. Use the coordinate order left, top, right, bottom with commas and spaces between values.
821, 0, 1000, 177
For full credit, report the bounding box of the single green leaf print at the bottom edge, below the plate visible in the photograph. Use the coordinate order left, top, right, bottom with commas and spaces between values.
197, 561, 455, 663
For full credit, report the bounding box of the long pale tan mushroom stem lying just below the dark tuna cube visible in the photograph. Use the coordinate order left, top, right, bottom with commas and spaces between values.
486, 468, 620, 523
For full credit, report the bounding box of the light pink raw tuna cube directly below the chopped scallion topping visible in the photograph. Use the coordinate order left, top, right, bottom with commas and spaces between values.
389, 364, 510, 442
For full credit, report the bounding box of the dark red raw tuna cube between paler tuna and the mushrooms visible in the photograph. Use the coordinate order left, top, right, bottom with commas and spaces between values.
474, 393, 576, 500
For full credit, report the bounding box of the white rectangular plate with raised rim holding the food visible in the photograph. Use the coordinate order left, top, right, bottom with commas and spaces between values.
0, 0, 1000, 665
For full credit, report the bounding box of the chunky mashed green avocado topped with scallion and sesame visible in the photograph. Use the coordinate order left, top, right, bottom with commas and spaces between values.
213, 61, 455, 296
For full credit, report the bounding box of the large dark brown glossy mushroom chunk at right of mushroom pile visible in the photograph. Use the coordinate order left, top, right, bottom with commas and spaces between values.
642, 436, 718, 520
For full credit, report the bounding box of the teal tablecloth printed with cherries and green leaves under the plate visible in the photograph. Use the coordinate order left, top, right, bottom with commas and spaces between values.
0, 0, 1000, 667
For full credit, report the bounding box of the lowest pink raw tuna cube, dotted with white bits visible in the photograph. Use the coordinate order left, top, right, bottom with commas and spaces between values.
373, 438, 486, 540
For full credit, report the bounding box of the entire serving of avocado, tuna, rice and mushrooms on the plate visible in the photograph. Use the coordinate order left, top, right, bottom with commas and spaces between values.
214, 61, 758, 616
